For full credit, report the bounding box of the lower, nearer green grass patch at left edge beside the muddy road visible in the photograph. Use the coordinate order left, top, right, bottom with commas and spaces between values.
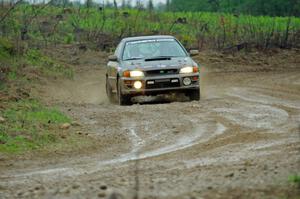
0, 100, 70, 153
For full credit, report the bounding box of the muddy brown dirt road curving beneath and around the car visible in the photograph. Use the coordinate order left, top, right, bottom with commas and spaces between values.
0, 47, 300, 199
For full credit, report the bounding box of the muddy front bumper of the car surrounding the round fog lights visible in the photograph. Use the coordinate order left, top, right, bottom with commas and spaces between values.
120, 73, 200, 96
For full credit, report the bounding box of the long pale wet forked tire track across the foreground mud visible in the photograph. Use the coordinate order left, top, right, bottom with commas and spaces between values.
2, 112, 227, 181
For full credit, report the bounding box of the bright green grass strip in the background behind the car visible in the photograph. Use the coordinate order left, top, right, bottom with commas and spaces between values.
68, 9, 300, 47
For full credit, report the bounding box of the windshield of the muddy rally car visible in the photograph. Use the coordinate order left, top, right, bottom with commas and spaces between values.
123, 39, 187, 60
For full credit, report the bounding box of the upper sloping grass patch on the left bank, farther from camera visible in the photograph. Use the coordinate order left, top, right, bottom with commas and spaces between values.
0, 37, 74, 81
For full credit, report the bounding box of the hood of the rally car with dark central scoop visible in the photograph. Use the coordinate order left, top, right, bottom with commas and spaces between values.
121, 57, 196, 71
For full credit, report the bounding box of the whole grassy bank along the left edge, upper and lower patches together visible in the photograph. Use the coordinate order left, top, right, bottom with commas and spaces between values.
0, 37, 78, 154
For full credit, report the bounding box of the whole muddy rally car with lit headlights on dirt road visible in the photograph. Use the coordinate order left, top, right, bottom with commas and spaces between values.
106, 36, 200, 105
